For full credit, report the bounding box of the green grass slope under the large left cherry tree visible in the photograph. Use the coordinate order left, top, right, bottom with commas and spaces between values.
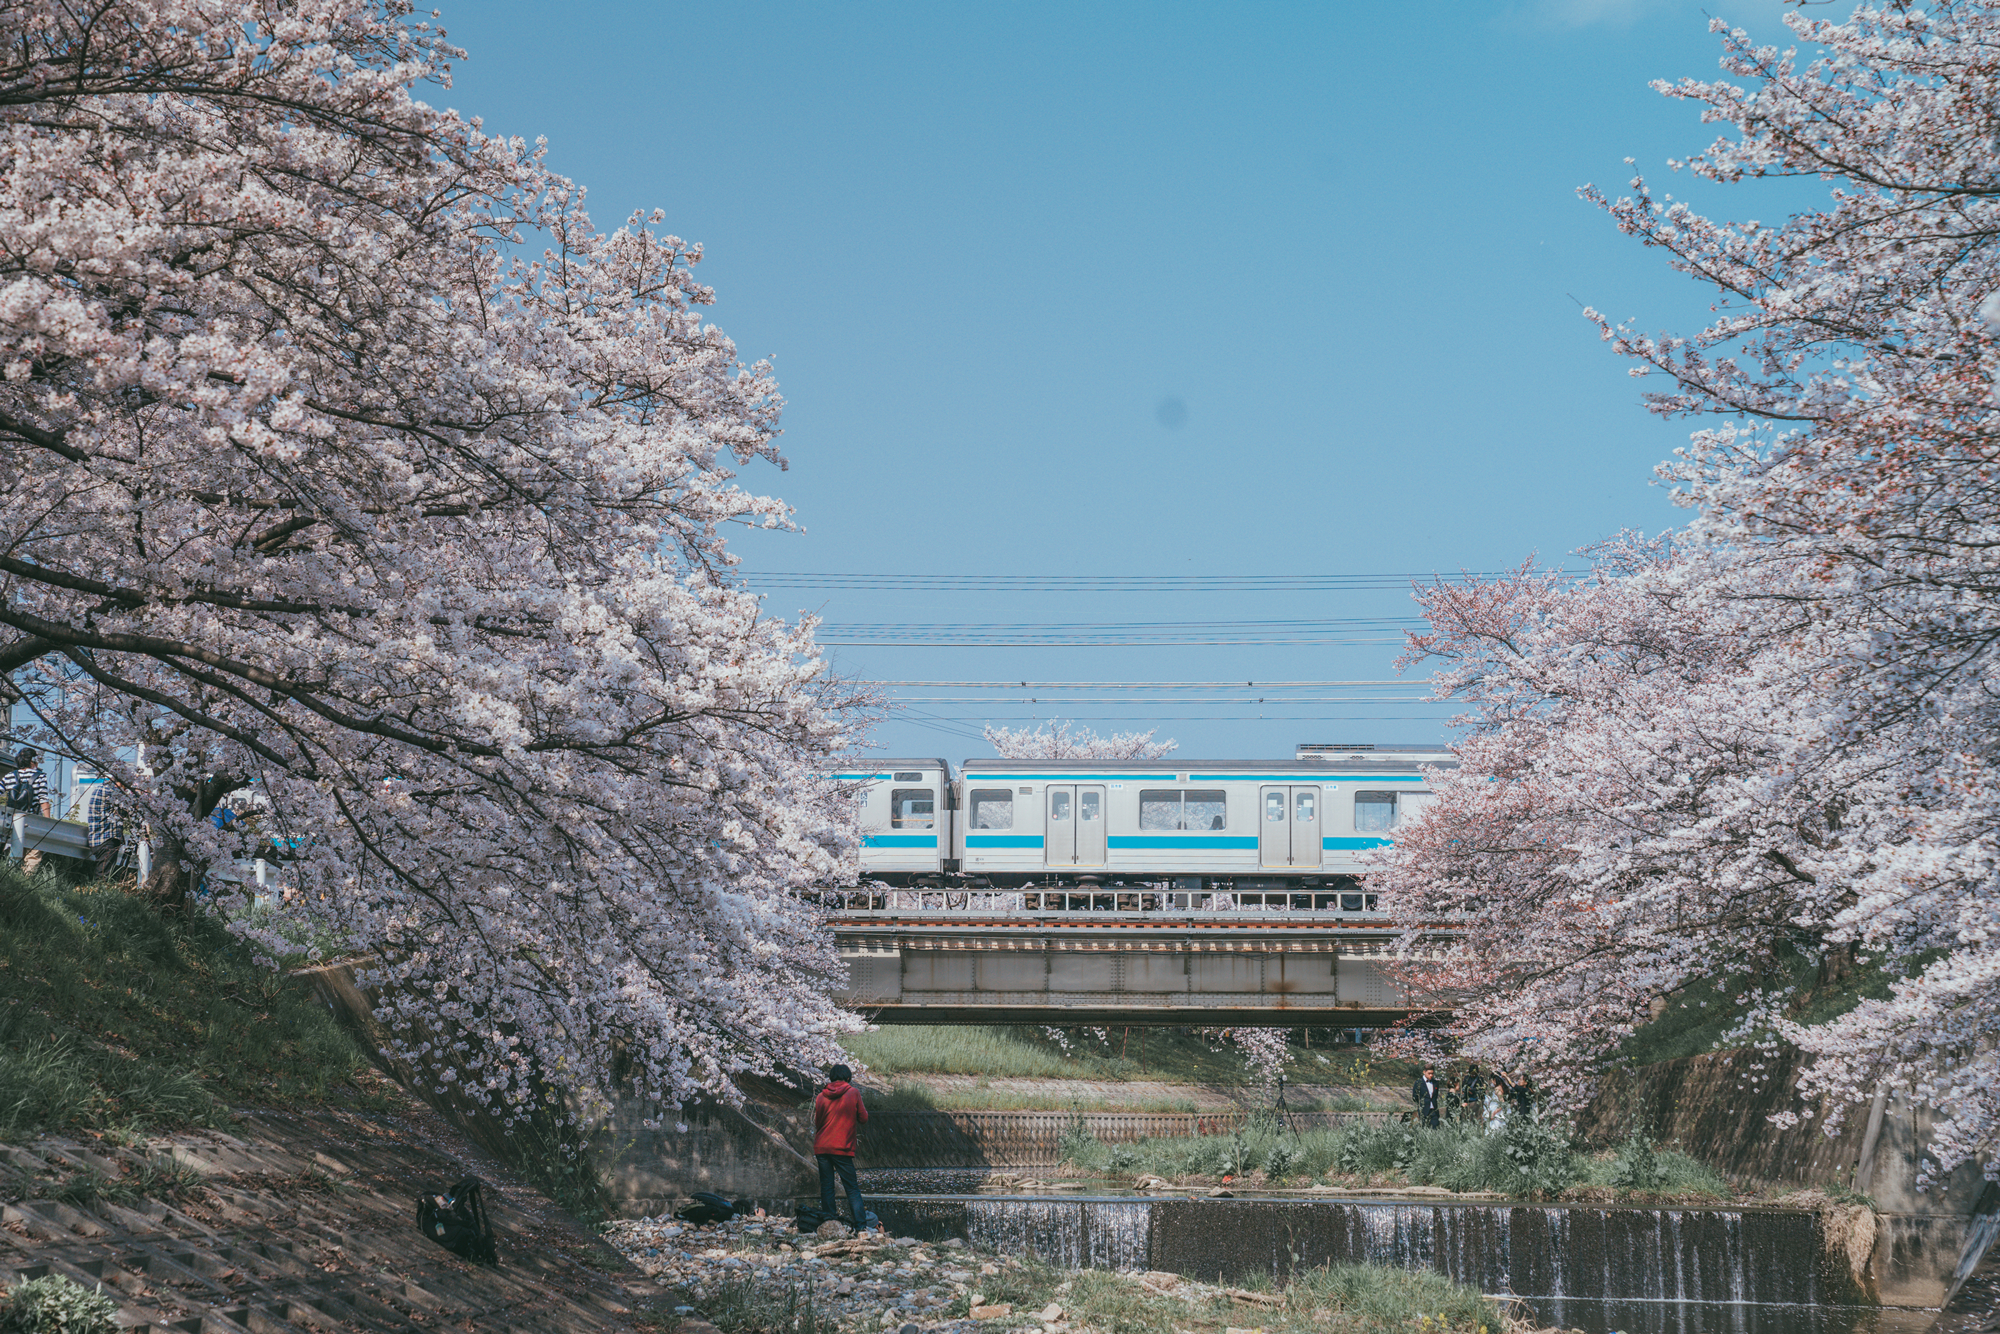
0, 866, 366, 1136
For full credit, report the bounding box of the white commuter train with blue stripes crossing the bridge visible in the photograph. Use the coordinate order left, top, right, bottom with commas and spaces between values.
838, 746, 1456, 912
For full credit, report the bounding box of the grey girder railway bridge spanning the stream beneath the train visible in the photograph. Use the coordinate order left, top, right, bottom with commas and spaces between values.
832, 896, 1408, 1028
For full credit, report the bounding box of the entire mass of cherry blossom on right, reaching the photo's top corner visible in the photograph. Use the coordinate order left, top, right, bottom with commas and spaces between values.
1386, 0, 2000, 1166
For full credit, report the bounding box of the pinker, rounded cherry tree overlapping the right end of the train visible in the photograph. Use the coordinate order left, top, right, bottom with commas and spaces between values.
1370, 538, 1844, 1102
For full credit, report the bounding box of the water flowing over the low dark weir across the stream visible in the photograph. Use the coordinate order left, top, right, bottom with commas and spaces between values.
870, 1196, 1896, 1334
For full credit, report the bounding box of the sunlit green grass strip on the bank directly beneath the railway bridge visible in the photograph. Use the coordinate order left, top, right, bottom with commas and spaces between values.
842, 1024, 1410, 1088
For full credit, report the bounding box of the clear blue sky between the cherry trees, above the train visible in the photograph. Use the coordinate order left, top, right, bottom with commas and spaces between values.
438, 0, 1786, 760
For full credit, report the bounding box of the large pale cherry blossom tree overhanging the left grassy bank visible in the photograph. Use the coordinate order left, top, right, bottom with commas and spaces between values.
0, 0, 858, 1106
